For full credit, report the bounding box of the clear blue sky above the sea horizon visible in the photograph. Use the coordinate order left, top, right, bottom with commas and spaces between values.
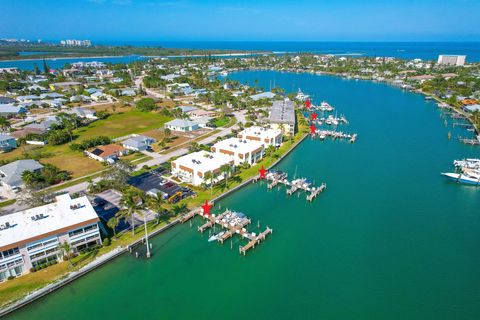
0, 0, 480, 41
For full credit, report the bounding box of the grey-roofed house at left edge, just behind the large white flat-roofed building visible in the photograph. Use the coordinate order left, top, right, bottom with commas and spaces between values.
0, 159, 43, 191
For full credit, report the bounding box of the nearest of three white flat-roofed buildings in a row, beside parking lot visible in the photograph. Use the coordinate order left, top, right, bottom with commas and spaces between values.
172, 150, 234, 186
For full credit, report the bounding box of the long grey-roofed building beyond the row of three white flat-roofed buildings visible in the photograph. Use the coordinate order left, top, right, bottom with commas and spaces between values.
268, 99, 296, 136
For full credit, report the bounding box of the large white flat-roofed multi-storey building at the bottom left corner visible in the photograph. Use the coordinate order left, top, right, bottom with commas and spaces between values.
0, 193, 102, 282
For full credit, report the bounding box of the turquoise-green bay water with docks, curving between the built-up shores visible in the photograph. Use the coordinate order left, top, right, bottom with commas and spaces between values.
7, 72, 480, 320
